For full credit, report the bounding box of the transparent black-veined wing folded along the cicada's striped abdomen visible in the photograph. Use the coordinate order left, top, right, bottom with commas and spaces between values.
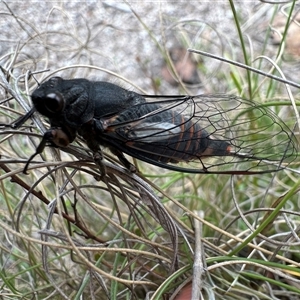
99, 95, 297, 174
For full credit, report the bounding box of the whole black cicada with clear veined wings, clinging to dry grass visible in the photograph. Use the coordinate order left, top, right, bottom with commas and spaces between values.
25, 77, 297, 174
